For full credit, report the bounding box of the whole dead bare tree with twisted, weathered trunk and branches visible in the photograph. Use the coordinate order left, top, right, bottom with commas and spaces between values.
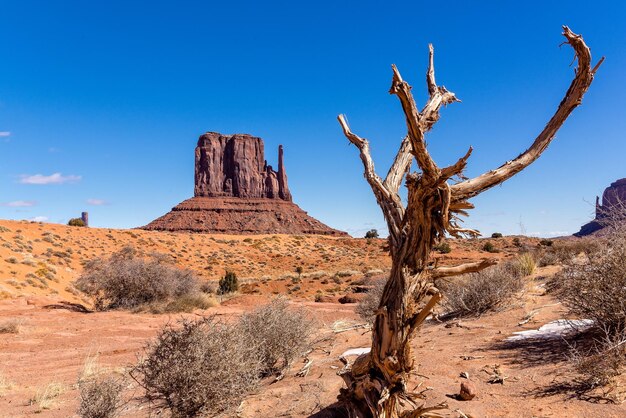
338, 26, 604, 418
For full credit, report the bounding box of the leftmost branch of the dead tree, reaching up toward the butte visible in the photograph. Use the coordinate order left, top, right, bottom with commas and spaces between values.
337, 115, 404, 244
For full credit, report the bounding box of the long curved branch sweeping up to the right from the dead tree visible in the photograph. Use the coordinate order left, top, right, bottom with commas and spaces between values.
452, 26, 602, 200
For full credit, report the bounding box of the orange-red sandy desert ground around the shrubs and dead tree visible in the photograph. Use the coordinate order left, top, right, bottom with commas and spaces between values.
0, 221, 626, 418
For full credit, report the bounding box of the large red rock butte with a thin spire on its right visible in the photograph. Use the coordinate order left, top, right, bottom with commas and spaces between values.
143, 132, 347, 236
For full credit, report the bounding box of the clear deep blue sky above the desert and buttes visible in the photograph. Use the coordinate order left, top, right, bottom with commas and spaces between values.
0, 0, 626, 236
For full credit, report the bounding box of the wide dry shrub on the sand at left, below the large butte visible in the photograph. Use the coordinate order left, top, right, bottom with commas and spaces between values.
74, 247, 200, 310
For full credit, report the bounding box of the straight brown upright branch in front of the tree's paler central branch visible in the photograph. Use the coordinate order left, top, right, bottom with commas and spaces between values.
389, 65, 439, 180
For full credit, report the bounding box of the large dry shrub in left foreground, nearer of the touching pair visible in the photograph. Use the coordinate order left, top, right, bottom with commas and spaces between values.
131, 317, 262, 417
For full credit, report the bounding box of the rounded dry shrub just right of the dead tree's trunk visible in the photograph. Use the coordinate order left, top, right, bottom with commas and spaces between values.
440, 262, 524, 316
